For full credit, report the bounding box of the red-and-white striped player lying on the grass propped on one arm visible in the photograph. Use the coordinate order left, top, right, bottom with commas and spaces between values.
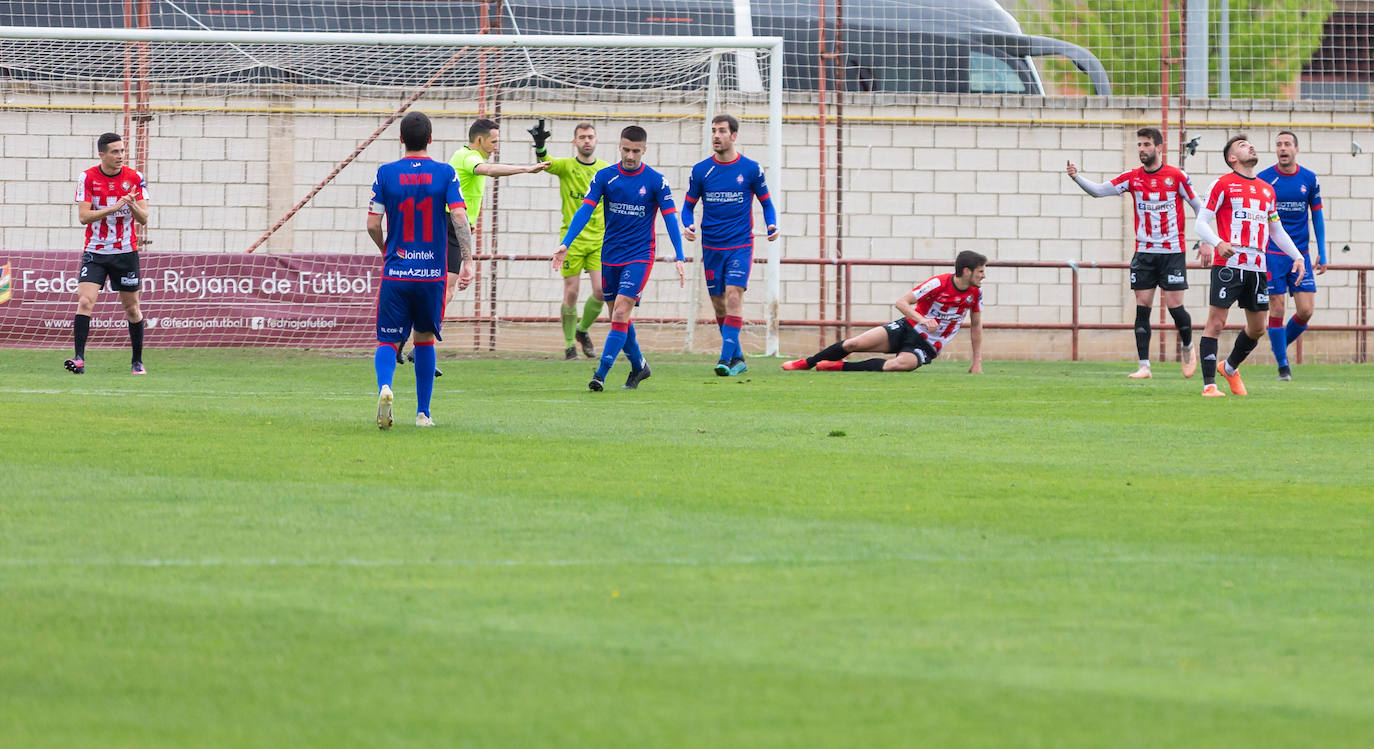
782, 250, 988, 374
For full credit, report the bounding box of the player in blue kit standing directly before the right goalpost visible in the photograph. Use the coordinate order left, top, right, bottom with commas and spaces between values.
683, 114, 778, 377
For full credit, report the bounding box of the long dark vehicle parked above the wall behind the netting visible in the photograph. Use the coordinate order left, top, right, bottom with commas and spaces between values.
0, 0, 1112, 95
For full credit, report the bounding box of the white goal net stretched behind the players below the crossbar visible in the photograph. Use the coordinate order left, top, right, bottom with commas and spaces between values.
0, 21, 780, 349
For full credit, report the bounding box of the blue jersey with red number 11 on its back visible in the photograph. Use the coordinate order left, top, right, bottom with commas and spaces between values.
367, 157, 464, 280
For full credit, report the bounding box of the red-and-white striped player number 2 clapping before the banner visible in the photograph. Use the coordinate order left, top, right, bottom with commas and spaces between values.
63, 133, 148, 375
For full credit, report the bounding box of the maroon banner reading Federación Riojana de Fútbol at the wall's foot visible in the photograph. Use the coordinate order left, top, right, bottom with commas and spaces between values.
0, 250, 382, 349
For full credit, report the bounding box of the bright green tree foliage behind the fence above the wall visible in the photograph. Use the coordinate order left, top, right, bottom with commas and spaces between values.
1018, 0, 1334, 99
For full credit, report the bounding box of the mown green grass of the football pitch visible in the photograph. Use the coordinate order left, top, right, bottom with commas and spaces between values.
0, 350, 1374, 748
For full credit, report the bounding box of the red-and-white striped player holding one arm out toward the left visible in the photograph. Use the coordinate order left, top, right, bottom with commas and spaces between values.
1068, 128, 1202, 379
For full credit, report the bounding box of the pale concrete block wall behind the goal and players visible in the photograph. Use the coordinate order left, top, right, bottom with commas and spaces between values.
0, 95, 1374, 359
